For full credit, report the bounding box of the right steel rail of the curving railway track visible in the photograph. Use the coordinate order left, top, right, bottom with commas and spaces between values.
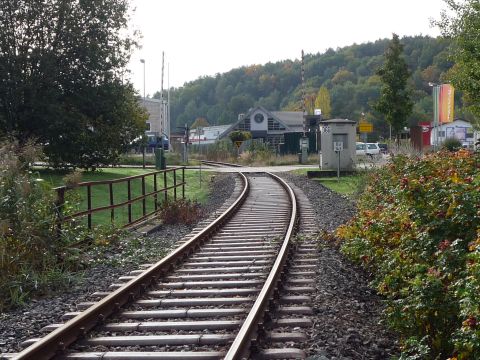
225, 173, 298, 360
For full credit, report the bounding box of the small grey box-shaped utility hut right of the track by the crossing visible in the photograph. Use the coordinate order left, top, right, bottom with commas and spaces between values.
320, 119, 357, 170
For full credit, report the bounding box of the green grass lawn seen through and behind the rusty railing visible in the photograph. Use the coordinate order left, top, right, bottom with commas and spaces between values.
34, 168, 213, 226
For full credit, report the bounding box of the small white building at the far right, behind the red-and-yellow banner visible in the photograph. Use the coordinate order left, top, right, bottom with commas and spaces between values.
430, 120, 478, 148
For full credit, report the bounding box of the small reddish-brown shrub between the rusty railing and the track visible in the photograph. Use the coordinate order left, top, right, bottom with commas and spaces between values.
159, 199, 202, 225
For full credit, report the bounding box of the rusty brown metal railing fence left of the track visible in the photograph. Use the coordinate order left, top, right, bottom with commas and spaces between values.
54, 167, 185, 231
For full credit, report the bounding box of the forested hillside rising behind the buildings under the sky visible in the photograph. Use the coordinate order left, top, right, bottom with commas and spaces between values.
156, 36, 461, 136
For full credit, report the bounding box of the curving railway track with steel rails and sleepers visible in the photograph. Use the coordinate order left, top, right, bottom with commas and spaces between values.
3, 169, 315, 360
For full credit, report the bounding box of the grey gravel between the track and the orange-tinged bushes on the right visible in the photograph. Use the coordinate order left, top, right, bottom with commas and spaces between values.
281, 173, 398, 360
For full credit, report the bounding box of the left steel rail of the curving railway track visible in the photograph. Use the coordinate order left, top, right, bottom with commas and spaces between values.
16, 173, 250, 360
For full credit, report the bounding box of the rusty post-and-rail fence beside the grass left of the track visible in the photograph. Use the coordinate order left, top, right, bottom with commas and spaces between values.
55, 167, 185, 229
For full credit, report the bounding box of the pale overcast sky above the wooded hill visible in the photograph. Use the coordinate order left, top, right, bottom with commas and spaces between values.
129, 0, 446, 95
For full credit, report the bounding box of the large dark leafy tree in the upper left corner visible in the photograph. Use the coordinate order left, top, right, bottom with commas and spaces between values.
0, 0, 146, 167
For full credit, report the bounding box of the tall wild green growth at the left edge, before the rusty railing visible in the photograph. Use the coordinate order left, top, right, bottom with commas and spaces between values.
0, 142, 101, 311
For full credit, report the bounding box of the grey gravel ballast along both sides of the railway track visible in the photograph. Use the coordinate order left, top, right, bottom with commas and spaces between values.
0, 173, 397, 360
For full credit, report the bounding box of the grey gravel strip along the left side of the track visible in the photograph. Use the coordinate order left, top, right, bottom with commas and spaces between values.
0, 173, 235, 353
